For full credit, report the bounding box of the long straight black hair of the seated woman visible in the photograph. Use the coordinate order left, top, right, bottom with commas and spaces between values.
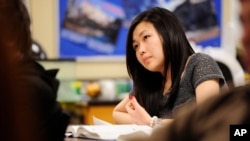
126, 7, 194, 116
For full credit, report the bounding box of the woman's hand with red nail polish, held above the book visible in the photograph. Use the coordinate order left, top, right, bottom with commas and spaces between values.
126, 96, 151, 125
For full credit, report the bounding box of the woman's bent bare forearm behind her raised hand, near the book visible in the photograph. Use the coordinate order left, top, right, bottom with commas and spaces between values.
113, 96, 133, 124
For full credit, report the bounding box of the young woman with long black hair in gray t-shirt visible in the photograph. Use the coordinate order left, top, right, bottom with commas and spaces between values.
113, 7, 225, 126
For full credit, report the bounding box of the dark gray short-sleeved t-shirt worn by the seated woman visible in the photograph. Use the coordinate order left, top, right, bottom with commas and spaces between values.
158, 53, 225, 118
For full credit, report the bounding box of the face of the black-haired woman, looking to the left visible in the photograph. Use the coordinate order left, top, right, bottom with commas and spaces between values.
133, 21, 164, 73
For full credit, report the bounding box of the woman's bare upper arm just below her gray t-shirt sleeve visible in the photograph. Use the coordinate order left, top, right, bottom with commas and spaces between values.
195, 79, 220, 104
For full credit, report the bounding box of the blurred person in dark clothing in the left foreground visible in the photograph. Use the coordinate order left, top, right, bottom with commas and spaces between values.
0, 0, 69, 141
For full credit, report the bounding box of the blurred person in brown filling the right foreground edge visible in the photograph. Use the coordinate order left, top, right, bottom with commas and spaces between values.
118, 0, 250, 141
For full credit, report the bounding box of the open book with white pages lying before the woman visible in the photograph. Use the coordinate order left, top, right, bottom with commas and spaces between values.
65, 119, 152, 140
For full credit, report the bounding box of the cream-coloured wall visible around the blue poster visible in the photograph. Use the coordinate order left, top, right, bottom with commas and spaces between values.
28, 0, 230, 79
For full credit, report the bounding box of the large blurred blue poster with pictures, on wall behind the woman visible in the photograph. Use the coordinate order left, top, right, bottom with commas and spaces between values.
58, 0, 222, 59
